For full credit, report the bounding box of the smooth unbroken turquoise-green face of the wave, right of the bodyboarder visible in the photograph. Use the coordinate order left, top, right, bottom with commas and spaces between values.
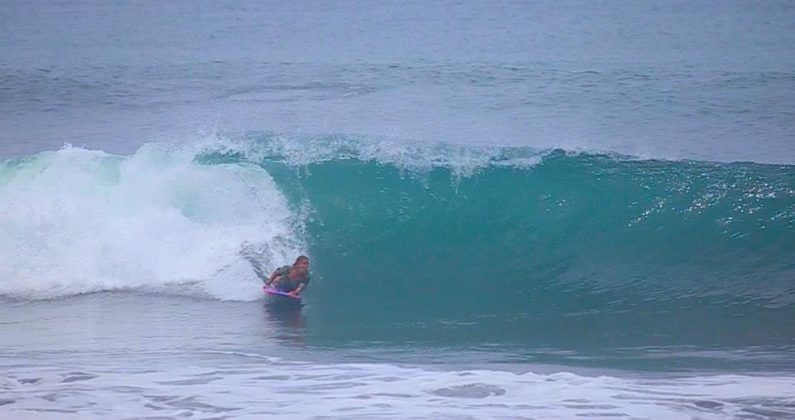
261, 152, 795, 345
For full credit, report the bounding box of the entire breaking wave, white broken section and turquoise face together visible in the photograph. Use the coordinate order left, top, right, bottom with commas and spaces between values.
0, 137, 795, 341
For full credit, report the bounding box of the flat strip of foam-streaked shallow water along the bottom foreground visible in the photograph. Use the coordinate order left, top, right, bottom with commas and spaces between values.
0, 352, 795, 419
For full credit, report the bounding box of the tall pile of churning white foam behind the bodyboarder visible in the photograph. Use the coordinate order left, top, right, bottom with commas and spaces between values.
0, 144, 303, 300
